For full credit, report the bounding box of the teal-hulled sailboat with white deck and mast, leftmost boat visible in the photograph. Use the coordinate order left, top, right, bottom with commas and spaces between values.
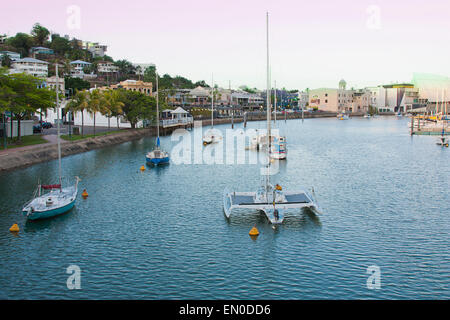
22, 65, 80, 220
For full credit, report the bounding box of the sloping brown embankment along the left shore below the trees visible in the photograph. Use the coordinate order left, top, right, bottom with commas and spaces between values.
0, 129, 154, 172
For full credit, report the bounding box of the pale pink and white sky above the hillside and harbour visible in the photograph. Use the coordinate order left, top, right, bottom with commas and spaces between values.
0, 0, 450, 90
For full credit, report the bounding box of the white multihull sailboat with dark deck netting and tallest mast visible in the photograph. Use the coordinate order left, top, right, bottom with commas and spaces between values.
223, 13, 320, 224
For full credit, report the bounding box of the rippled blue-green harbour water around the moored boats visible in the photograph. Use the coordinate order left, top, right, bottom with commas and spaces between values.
0, 118, 450, 299
